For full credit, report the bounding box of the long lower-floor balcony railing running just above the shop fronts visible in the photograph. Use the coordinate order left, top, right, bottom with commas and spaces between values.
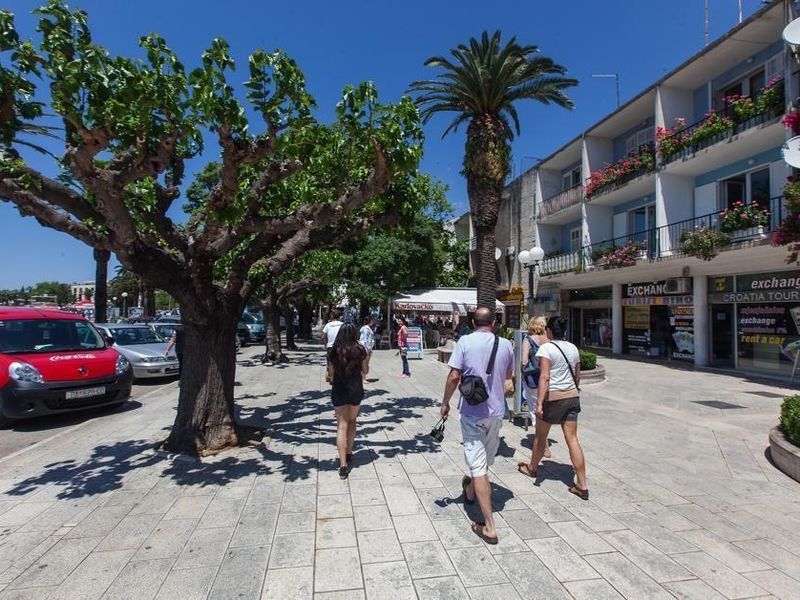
540, 197, 786, 275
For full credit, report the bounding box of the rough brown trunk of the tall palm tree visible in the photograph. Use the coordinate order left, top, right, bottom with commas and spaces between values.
464, 114, 510, 311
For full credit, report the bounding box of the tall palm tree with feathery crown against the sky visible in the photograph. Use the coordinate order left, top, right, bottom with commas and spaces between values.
410, 31, 578, 310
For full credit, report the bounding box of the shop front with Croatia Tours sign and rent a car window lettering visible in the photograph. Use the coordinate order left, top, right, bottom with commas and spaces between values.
708, 271, 800, 376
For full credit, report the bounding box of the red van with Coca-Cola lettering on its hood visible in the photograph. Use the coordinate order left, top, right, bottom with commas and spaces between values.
0, 306, 133, 425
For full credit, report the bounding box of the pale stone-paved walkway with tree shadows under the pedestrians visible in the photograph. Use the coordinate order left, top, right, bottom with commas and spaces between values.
0, 349, 800, 600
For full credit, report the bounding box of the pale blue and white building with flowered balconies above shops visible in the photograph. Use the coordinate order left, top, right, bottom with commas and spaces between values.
498, 0, 800, 374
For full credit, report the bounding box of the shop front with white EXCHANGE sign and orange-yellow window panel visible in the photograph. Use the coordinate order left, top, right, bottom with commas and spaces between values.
622, 278, 694, 362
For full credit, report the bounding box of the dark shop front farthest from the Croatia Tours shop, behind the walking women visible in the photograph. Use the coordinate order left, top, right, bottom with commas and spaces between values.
567, 286, 613, 350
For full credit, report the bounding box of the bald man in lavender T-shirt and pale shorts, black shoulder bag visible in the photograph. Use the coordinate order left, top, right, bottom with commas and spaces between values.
441, 308, 514, 544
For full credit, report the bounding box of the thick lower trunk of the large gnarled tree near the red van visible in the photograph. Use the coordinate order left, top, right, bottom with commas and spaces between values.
165, 307, 239, 455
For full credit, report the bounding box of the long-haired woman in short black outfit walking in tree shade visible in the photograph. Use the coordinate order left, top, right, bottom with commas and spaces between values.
326, 323, 367, 479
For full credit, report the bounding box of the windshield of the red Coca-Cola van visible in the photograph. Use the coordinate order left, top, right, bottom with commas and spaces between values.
0, 319, 106, 354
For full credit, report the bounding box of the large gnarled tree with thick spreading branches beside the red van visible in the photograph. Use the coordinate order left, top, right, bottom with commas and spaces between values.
0, 0, 422, 453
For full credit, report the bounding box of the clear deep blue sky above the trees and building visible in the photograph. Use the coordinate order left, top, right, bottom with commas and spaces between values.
0, 0, 776, 289
